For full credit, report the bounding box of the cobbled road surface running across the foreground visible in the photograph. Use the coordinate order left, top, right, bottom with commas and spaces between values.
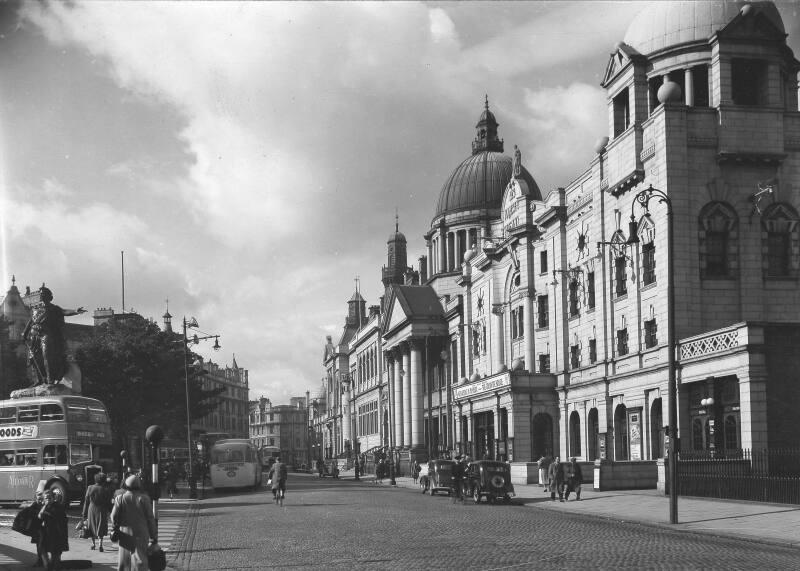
171, 474, 800, 571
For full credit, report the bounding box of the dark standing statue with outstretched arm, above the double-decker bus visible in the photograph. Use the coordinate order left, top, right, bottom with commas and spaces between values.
22, 284, 86, 386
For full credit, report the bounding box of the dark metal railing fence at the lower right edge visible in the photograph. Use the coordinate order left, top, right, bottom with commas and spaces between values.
678, 448, 800, 504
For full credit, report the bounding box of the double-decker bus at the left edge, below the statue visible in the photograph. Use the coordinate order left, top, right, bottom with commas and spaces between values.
0, 395, 113, 503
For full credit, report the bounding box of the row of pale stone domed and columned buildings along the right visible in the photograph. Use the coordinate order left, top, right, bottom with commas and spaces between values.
316, 2, 800, 487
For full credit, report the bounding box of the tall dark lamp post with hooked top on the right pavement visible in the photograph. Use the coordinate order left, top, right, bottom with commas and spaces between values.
628, 184, 678, 523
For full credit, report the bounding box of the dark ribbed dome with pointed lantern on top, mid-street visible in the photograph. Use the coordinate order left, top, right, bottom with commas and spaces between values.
434, 100, 542, 218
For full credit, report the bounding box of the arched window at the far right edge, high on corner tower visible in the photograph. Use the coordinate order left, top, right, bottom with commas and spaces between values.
761, 202, 800, 278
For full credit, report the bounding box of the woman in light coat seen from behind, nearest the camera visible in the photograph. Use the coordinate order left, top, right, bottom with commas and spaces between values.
111, 476, 158, 571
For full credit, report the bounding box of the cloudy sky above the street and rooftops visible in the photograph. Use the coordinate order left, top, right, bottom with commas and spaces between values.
0, 1, 800, 404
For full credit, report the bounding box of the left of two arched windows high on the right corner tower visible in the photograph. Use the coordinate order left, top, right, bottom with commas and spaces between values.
698, 201, 739, 279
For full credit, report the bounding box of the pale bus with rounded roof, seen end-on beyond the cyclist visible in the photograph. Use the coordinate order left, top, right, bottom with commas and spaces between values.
209, 438, 262, 490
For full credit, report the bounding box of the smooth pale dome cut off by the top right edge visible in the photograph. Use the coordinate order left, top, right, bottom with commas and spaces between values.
624, 1, 785, 55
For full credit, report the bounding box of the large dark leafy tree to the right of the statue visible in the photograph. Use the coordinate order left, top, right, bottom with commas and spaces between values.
75, 315, 222, 454
